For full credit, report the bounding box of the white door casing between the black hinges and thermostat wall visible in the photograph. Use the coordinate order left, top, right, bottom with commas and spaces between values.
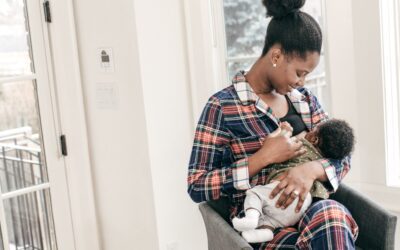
38, 0, 101, 250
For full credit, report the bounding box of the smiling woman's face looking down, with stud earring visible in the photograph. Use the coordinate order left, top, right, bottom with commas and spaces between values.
268, 50, 320, 95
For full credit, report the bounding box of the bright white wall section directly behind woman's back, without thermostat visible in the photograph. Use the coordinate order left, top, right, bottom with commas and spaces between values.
134, 0, 207, 250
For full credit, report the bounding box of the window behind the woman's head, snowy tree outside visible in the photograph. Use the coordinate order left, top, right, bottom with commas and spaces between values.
221, 0, 329, 110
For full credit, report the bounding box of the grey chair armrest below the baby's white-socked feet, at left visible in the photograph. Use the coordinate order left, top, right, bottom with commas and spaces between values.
199, 202, 253, 250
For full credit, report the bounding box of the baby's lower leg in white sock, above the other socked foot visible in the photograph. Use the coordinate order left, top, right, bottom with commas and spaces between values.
232, 189, 262, 232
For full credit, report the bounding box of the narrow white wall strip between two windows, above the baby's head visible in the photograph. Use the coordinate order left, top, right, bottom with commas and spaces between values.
324, 0, 361, 182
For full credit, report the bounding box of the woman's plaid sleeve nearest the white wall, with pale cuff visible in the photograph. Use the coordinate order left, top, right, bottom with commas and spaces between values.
187, 97, 250, 202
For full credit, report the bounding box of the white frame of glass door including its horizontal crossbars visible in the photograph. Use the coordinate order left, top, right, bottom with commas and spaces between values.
0, 0, 75, 250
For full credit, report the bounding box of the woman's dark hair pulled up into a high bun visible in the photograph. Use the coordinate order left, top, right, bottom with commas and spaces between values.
262, 0, 322, 59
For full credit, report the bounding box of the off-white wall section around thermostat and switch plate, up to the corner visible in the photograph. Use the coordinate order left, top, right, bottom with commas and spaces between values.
74, 0, 158, 250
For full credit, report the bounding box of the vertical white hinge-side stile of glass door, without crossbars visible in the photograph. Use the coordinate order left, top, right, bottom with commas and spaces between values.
26, 0, 75, 250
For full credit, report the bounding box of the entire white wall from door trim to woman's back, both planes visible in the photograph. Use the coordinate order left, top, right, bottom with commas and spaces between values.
71, 0, 207, 250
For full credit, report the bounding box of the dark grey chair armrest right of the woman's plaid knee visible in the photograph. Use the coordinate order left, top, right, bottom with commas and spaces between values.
330, 184, 397, 250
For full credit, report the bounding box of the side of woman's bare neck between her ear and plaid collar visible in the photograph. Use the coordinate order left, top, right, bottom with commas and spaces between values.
245, 57, 274, 95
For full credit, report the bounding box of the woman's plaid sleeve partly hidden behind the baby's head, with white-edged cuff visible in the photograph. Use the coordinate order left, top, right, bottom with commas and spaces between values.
307, 91, 351, 193
